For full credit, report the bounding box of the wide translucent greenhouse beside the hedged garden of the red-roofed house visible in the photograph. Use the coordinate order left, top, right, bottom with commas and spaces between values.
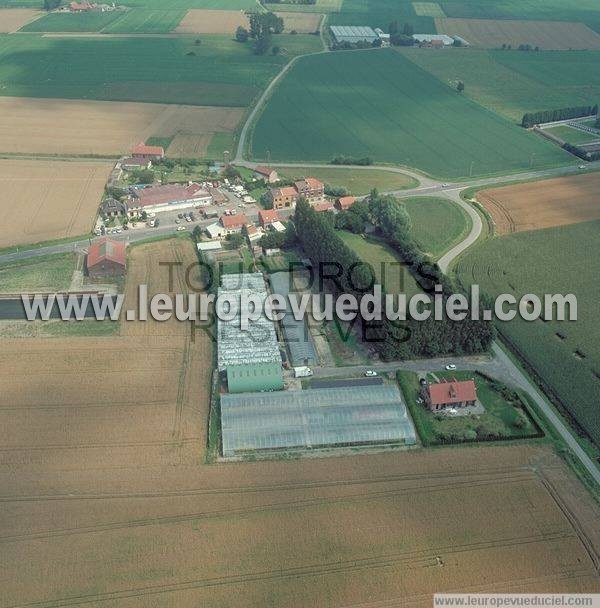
221, 384, 416, 456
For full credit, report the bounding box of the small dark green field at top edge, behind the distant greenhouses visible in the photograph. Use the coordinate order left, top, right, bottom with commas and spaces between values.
327, 0, 436, 34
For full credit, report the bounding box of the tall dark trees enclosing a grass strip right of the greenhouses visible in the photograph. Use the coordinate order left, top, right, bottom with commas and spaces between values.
294, 191, 494, 360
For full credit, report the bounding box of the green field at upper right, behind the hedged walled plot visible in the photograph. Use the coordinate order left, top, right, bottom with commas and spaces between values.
402, 49, 600, 123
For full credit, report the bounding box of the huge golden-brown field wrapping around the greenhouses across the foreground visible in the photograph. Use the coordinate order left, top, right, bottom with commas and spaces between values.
0, 240, 600, 608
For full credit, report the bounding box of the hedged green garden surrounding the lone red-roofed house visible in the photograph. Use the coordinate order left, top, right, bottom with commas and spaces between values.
397, 371, 543, 446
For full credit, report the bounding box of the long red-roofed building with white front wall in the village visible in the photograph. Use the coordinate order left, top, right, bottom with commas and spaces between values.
127, 183, 212, 217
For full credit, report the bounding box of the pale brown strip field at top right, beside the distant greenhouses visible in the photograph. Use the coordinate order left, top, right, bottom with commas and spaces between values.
435, 17, 600, 51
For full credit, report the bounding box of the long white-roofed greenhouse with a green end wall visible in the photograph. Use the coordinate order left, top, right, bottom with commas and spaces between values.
217, 273, 283, 393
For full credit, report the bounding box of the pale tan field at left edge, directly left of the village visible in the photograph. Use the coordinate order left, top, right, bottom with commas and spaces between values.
0, 160, 112, 248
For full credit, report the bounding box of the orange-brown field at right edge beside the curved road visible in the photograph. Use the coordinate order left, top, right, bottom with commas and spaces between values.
477, 172, 600, 235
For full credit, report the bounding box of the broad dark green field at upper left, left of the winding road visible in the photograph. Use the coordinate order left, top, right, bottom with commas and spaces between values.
0, 34, 320, 107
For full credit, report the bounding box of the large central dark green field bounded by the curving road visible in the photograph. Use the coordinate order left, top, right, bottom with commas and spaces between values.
252, 49, 573, 178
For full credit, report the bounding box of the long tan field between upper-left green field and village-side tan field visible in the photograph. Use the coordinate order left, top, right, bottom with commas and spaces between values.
0, 97, 243, 156
